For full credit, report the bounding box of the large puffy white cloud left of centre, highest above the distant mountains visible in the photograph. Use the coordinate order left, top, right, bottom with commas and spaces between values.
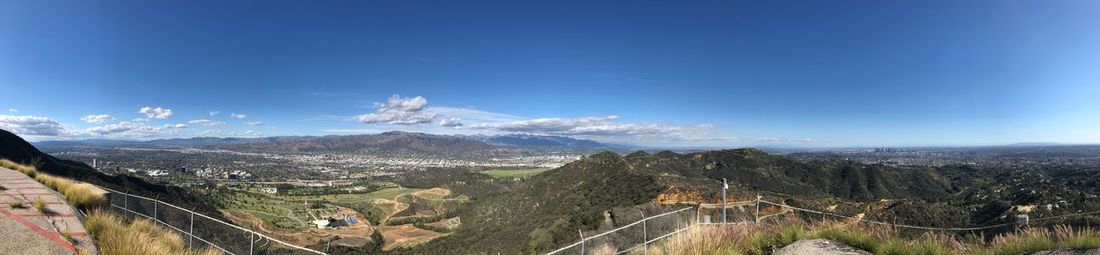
355, 95, 436, 125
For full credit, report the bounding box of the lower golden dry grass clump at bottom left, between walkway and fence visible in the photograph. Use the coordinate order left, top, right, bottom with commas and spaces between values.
84, 210, 221, 255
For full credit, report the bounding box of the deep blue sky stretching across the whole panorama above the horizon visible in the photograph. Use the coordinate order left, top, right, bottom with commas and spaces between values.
0, 0, 1100, 146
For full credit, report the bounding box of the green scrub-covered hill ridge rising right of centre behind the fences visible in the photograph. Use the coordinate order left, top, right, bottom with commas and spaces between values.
404, 149, 952, 254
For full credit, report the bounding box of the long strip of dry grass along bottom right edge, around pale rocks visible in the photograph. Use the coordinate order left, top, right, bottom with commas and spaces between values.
649, 220, 1100, 255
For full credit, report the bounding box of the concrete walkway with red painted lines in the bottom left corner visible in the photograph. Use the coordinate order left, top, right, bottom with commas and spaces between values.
0, 167, 99, 254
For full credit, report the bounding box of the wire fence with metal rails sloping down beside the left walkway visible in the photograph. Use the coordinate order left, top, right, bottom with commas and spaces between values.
99, 187, 325, 255
